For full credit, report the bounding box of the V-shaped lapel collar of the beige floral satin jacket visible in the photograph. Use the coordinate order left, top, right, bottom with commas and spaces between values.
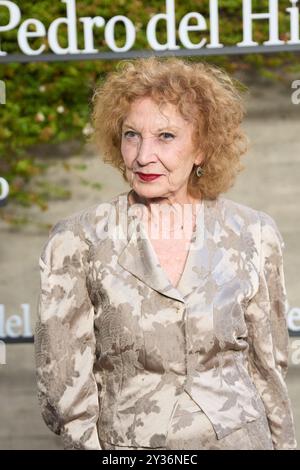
118, 193, 218, 303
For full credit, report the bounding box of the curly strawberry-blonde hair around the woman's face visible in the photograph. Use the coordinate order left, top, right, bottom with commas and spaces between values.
90, 57, 249, 199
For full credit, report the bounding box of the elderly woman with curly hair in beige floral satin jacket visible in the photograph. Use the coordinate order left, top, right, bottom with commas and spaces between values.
36, 57, 296, 449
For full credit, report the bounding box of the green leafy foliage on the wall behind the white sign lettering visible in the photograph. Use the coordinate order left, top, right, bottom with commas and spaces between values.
0, 0, 300, 224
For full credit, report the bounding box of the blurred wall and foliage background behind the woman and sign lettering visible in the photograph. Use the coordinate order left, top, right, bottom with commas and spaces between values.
0, 0, 300, 449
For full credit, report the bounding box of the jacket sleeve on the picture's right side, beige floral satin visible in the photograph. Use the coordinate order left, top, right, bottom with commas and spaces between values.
245, 211, 297, 449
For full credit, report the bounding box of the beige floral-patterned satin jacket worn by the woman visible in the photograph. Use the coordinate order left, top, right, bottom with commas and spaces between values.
35, 192, 296, 450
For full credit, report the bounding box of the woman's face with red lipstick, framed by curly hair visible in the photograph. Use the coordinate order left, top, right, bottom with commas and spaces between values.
121, 97, 203, 203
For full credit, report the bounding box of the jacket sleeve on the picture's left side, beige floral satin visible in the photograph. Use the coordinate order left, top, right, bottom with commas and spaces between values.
35, 222, 101, 450
